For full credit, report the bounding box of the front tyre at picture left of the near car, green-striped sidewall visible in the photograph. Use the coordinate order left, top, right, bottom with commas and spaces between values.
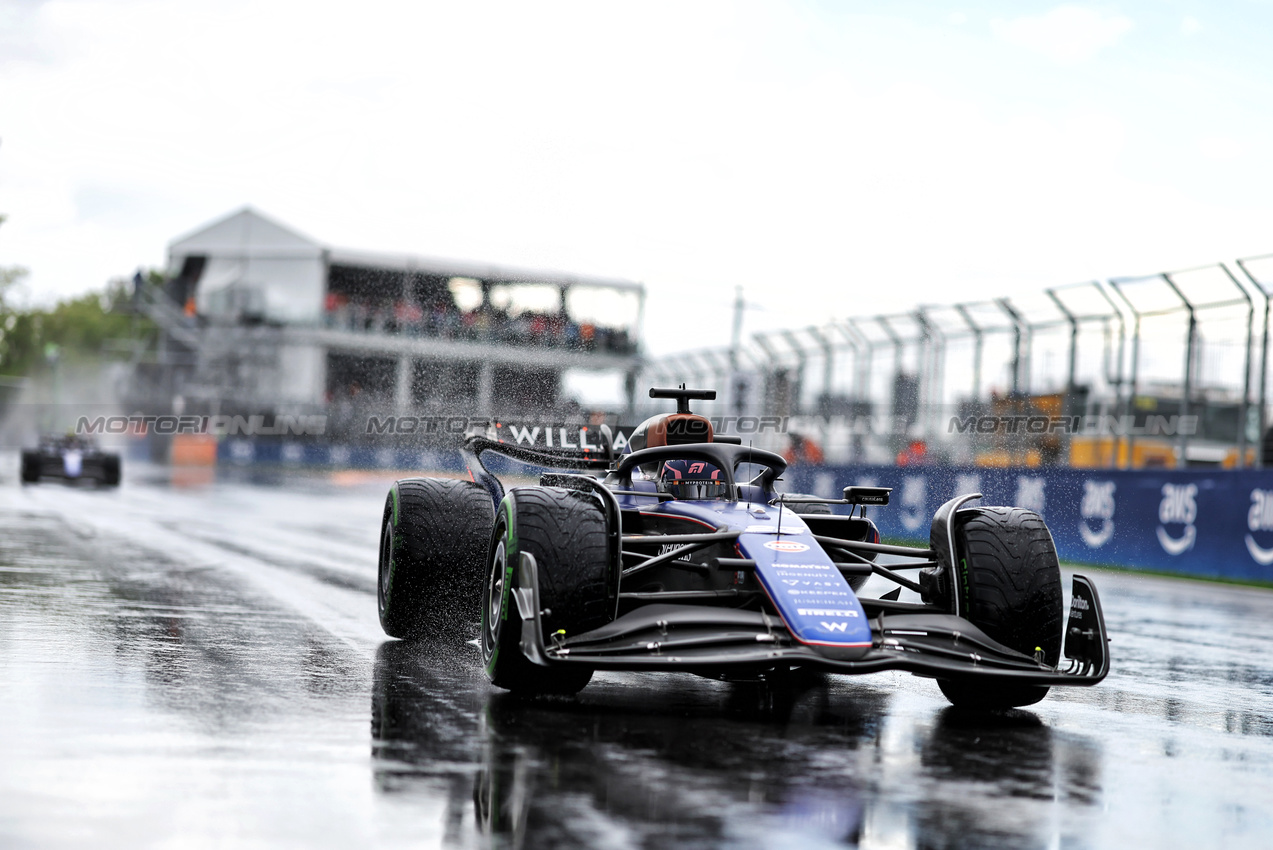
481, 487, 614, 693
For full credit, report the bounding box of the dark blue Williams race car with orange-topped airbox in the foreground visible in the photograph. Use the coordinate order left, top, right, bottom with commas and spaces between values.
378, 386, 1109, 707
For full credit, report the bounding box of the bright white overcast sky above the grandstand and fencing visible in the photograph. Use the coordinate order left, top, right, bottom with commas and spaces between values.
0, 0, 1273, 354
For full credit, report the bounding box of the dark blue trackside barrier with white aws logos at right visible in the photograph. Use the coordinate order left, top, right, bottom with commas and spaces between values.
783, 466, 1273, 582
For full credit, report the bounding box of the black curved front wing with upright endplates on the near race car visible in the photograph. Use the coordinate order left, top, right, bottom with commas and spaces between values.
512, 552, 1109, 686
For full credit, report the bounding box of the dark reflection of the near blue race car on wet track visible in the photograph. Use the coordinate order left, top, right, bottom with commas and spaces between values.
373, 643, 1100, 847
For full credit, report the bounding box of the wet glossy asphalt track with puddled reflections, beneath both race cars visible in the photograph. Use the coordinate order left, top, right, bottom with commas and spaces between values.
0, 468, 1273, 849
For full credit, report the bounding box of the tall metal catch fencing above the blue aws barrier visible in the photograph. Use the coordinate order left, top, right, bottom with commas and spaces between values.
638, 254, 1273, 468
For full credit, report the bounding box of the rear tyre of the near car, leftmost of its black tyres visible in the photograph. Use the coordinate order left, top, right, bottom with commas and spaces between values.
377, 478, 494, 639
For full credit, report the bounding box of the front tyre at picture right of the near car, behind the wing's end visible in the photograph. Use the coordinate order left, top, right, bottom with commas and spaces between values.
933, 508, 1063, 709
